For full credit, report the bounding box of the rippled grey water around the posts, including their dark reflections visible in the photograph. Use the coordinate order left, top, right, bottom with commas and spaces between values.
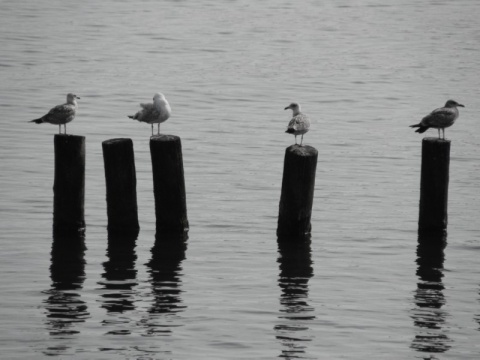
0, 0, 480, 359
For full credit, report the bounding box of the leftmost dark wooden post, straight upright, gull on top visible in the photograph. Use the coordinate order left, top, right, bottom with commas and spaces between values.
53, 134, 85, 233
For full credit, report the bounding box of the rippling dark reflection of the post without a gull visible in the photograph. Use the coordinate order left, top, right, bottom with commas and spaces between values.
99, 230, 138, 316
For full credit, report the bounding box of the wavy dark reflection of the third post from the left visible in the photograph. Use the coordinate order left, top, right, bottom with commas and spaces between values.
142, 232, 188, 336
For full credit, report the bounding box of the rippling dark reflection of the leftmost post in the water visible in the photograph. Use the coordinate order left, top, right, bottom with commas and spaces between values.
44, 233, 90, 340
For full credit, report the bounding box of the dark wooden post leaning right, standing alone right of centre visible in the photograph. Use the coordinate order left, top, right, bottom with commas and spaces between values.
277, 145, 318, 238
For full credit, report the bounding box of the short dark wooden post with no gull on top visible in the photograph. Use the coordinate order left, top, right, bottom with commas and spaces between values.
102, 139, 140, 233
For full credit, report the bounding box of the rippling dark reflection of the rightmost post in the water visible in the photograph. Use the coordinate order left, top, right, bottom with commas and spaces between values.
411, 232, 452, 353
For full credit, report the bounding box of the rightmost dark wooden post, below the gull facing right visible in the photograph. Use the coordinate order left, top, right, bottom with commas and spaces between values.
418, 138, 450, 232
